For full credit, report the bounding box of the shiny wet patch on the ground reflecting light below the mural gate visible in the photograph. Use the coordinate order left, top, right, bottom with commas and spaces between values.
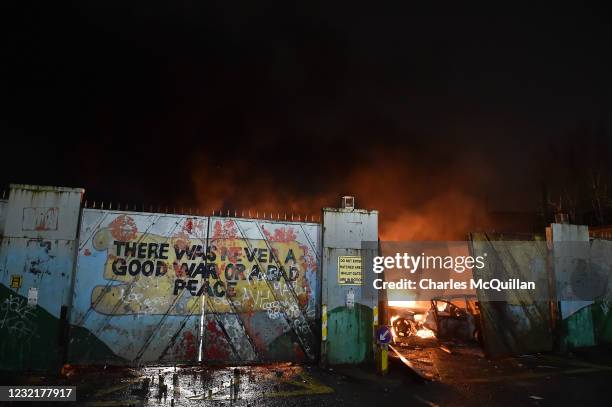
80, 364, 333, 406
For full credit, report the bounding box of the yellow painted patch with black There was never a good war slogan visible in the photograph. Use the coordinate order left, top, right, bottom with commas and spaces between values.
91, 215, 316, 318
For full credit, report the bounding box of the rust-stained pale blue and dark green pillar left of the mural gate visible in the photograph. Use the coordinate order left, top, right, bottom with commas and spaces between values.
0, 185, 83, 370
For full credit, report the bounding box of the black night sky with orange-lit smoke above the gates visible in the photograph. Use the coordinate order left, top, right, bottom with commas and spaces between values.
0, 1, 612, 238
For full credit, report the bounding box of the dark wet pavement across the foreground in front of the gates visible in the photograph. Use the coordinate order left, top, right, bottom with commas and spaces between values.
2, 346, 612, 407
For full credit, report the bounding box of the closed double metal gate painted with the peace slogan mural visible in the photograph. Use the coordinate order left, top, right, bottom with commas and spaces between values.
70, 209, 320, 364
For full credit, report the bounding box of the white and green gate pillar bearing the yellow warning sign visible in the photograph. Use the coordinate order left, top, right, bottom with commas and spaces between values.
321, 208, 378, 364
